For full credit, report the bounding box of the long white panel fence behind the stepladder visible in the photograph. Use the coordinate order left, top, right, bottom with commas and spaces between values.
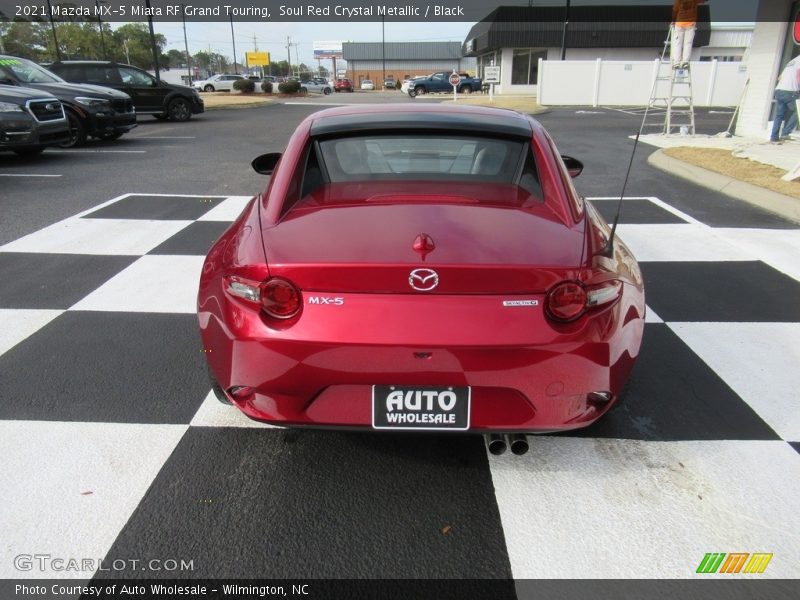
537, 58, 747, 106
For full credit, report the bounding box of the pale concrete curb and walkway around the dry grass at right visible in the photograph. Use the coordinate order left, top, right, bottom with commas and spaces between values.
639, 134, 800, 223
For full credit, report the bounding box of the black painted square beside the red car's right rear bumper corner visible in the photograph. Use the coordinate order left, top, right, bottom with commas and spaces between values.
566, 323, 780, 441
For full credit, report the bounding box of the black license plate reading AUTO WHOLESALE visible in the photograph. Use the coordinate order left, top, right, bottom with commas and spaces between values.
372, 385, 470, 430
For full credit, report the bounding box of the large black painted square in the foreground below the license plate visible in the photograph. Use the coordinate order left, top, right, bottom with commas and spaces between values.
98, 428, 513, 580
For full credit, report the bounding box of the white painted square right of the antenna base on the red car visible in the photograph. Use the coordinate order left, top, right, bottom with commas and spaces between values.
618, 224, 753, 262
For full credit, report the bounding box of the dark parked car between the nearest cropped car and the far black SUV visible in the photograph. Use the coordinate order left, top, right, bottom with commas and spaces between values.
0, 55, 136, 147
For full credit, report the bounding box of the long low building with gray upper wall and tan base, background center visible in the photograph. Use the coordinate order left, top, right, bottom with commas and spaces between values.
342, 42, 476, 87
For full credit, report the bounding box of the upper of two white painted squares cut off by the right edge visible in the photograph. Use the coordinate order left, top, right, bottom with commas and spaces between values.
715, 229, 800, 286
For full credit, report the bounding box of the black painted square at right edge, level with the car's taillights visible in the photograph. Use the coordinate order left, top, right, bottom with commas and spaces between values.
640, 261, 800, 322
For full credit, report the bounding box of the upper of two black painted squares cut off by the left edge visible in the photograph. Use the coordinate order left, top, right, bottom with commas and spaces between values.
0, 252, 138, 309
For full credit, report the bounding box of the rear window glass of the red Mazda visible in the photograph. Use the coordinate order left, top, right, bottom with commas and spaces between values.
319, 134, 527, 183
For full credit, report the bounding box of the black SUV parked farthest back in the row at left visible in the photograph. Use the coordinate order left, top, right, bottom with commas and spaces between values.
50, 60, 205, 121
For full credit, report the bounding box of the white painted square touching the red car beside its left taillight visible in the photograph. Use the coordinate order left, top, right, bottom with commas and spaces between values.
70, 256, 204, 313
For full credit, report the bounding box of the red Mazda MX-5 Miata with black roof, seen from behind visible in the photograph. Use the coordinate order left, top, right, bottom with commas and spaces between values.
198, 104, 645, 451
